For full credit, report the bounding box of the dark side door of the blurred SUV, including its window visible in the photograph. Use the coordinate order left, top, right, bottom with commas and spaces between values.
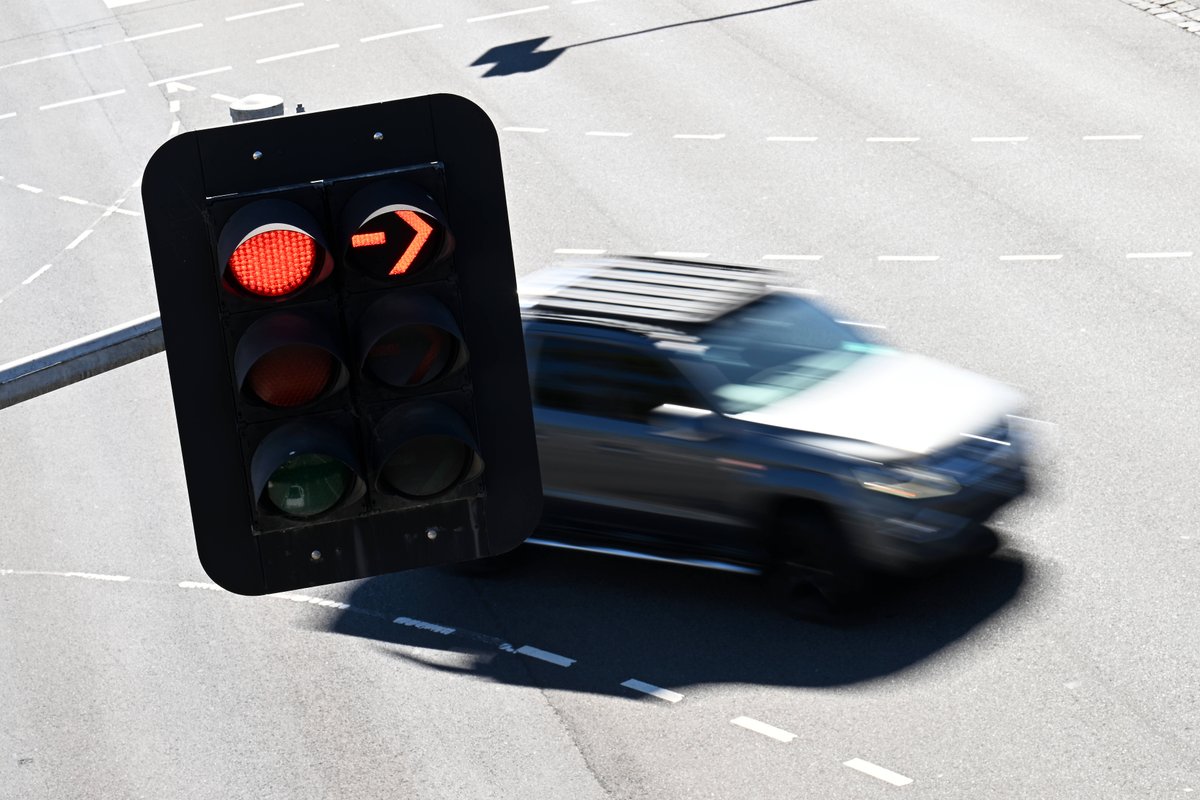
534, 336, 732, 545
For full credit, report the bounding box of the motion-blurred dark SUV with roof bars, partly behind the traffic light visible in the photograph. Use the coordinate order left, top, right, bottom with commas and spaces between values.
520, 258, 1026, 615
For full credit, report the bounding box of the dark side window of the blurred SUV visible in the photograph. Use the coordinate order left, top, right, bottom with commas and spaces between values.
534, 337, 696, 422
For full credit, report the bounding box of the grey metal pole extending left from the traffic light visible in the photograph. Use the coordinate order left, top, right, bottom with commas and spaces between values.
0, 314, 163, 408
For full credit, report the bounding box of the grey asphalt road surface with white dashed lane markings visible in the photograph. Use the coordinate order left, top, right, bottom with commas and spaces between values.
0, 0, 1200, 800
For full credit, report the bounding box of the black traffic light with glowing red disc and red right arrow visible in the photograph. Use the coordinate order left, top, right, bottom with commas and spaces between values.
143, 95, 541, 595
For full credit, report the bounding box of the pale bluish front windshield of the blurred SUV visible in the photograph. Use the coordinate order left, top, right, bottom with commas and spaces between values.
697, 293, 889, 414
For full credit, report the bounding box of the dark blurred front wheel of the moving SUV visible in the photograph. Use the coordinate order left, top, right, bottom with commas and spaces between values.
767, 506, 866, 625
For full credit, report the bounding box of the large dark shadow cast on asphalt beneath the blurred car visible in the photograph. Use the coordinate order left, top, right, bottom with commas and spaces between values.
314, 537, 1027, 696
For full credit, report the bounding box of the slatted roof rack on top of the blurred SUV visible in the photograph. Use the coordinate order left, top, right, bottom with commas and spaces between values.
521, 255, 779, 330
